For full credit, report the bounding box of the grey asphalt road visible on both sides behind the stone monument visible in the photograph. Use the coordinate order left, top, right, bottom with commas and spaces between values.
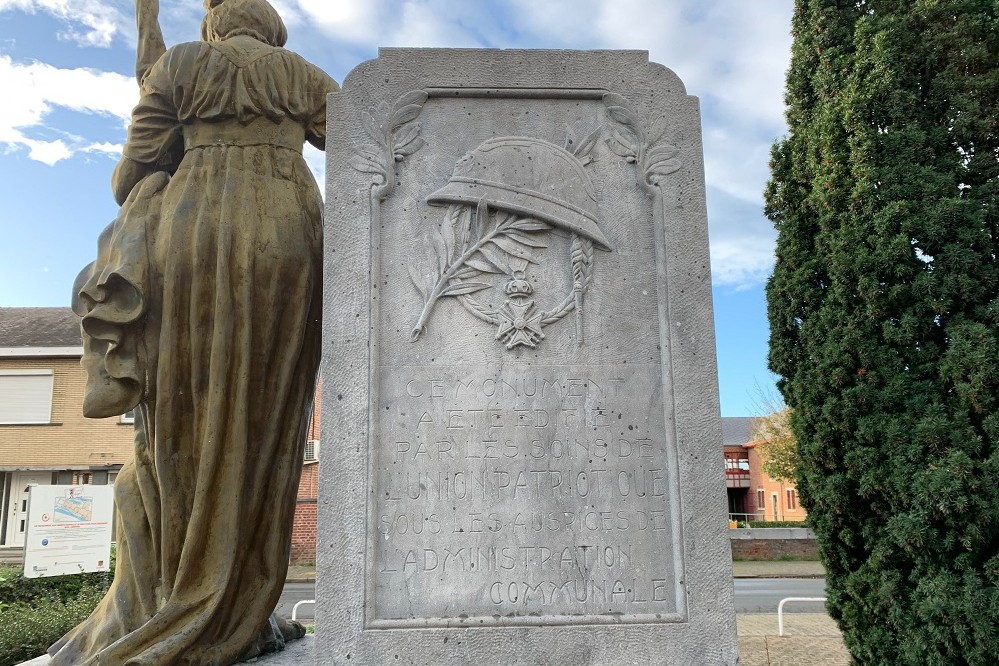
278, 578, 825, 621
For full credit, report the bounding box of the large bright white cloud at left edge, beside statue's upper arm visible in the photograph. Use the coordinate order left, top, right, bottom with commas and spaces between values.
0, 53, 138, 165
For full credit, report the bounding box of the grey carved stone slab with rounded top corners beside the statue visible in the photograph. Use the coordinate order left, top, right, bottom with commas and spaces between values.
317, 49, 736, 666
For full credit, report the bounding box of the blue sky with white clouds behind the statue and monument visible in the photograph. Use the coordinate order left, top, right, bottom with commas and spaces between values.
0, 0, 792, 416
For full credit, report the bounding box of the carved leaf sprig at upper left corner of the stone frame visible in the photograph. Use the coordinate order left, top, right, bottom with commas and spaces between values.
350, 90, 427, 186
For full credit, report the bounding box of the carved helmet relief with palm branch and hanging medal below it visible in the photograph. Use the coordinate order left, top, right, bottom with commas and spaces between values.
410, 137, 611, 349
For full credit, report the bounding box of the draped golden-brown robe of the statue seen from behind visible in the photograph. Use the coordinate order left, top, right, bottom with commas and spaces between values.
50, 36, 336, 666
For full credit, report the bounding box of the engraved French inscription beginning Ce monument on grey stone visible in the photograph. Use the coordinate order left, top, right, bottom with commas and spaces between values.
369, 364, 683, 626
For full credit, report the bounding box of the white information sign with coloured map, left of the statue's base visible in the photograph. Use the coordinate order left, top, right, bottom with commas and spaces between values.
24, 486, 114, 578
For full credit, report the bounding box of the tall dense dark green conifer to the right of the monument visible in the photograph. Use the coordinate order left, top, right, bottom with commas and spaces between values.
766, 0, 999, 666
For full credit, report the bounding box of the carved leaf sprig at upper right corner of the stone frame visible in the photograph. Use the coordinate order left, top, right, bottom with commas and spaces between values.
603, 93, 682, 186
